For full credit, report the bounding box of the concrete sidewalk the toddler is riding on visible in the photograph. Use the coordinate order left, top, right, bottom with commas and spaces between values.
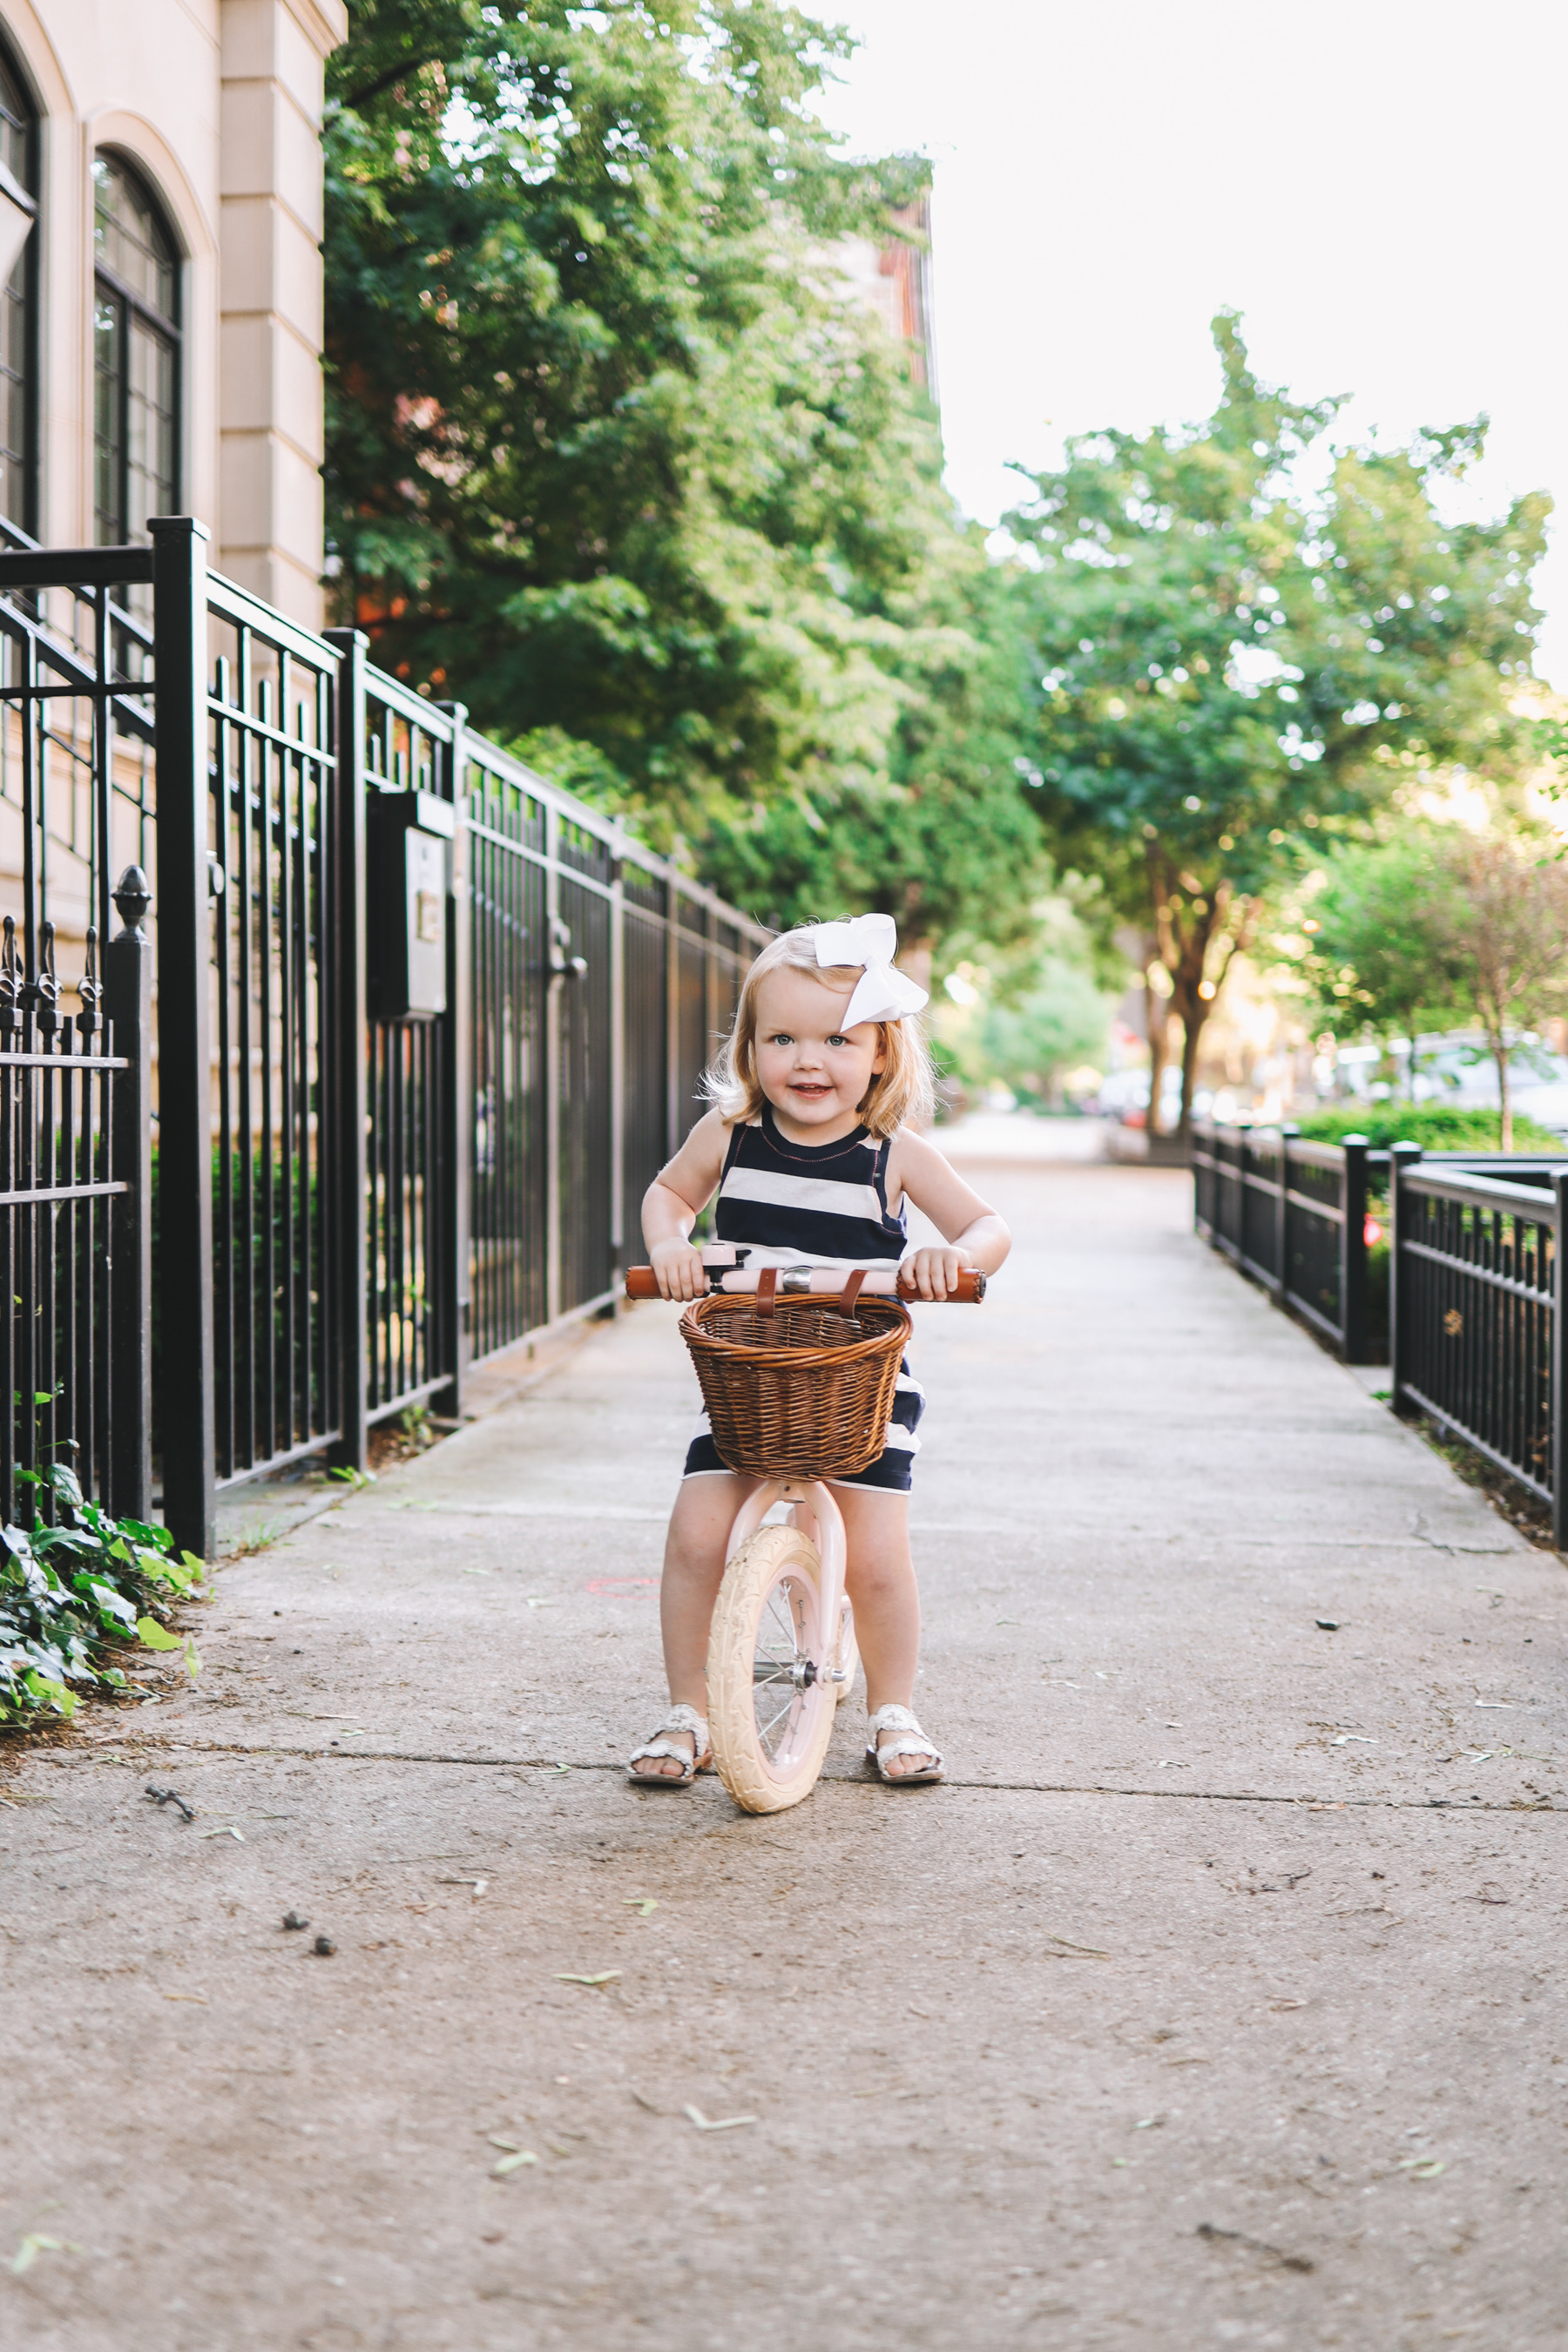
0, 1169, 1568, 2352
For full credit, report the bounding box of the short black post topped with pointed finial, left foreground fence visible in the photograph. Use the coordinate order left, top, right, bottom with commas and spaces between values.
104, 866, 152, 1524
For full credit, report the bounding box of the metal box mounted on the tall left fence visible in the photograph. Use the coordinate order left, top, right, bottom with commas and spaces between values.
364, 793, 456, 1021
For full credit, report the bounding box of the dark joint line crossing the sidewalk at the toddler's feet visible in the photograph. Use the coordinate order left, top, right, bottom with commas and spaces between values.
28, 1738, 1568, 1814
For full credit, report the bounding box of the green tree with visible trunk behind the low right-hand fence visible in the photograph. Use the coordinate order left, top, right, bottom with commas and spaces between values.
1009, 313, 1549, 1129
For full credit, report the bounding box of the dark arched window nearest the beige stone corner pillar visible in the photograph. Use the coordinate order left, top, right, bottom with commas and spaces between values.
91, 155, 181, 548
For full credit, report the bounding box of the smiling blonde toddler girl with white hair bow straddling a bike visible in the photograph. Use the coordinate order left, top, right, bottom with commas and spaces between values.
628, 915, 1010, 1788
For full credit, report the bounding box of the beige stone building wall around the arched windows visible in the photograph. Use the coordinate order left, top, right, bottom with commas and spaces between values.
0, 0, 348, 624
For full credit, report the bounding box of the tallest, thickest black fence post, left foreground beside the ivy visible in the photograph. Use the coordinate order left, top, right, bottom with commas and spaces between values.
151, 515, 216, 1559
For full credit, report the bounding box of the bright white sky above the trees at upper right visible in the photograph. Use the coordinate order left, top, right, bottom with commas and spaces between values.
811, 0, 1568, 686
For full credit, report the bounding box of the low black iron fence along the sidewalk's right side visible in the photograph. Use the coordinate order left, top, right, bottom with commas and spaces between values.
1192, 1119, 1568, 1550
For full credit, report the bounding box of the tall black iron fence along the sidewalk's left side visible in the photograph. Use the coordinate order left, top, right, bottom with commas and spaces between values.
0, 517, 767, 1552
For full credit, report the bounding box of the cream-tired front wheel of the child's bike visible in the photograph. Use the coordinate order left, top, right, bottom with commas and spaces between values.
707, 1526, 837, 1814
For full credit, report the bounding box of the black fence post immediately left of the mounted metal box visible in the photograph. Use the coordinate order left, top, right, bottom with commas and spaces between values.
322, 628, 369, 1470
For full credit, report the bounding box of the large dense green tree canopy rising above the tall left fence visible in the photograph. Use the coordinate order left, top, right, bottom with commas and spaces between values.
327, 0, 1039, 955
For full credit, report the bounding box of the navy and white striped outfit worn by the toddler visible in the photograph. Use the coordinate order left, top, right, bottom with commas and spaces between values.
684, 1103, 926, 1494
